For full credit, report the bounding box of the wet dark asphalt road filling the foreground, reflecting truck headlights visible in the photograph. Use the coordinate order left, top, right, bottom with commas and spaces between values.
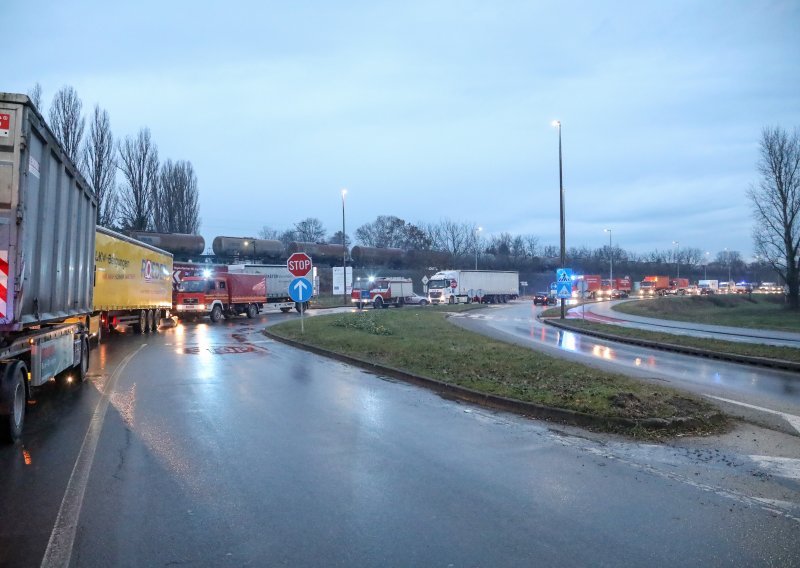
0, 314, 800, 567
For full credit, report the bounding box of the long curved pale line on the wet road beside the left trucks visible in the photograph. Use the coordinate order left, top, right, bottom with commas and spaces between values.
41, 343, 147, 568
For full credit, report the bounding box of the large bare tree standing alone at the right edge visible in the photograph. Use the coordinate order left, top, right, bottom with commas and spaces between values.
747, 127, 800, 310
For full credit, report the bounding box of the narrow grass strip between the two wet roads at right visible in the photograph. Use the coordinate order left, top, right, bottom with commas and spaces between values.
558, 318, 800, 363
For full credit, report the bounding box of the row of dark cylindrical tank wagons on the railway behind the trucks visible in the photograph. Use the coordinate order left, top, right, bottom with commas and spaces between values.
132, 231, 450, 268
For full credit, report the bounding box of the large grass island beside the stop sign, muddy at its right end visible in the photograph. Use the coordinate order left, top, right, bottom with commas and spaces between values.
269, 307, 719, 434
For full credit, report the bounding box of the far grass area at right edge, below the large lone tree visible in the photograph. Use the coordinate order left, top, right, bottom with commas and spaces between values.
614, 294, 800, 332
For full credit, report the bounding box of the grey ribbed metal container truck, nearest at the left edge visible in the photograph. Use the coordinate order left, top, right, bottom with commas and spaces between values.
0, 93, 97, 442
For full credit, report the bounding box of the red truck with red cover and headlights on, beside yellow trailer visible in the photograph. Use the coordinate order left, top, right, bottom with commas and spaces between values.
175, 272, 267, 323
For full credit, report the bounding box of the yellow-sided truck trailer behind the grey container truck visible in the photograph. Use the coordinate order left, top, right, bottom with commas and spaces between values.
94, 227, 173, 343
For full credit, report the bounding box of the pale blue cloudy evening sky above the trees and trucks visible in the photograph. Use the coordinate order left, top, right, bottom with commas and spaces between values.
7, 0, 800, 259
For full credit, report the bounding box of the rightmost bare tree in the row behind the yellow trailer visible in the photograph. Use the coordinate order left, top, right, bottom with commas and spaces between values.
152, 160, 200, 235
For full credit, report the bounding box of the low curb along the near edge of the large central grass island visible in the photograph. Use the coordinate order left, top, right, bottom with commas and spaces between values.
261, 329, 726, 432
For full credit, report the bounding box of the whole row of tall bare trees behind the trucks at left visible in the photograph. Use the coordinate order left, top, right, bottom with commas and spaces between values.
28, 83, 200, 234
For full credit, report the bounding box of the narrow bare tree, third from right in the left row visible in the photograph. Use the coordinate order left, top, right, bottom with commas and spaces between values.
82, 105, 119, 227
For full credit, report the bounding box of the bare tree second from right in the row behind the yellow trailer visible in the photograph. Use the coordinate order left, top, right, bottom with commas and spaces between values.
118, 128, 158, 231
